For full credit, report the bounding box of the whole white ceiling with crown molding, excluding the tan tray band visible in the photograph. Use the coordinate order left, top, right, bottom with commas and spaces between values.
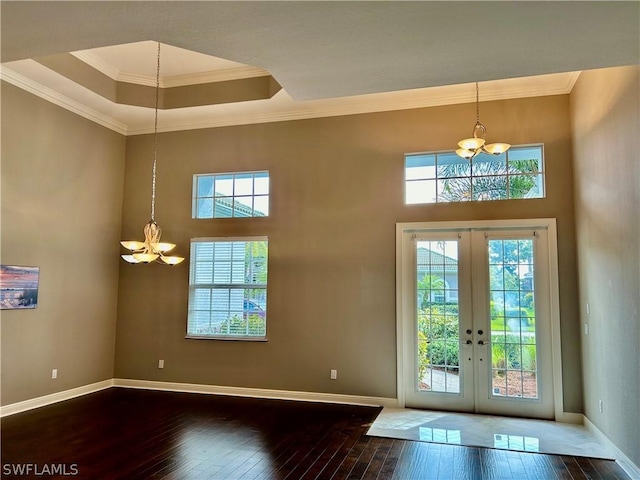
0, 1, 640, 134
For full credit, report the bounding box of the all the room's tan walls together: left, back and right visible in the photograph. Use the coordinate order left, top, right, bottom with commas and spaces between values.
1, 62, 640, 464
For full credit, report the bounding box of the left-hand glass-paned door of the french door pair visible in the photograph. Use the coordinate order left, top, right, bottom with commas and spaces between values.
403, 232, 474, 411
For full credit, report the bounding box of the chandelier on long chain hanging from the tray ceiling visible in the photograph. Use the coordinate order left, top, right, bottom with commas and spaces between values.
120, 42, 184, 265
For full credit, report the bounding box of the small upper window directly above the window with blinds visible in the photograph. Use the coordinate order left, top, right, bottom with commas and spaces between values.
192, 171, 269, 218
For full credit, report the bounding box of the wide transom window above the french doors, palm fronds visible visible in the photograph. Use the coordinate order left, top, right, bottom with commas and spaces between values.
404, 145, 545, 205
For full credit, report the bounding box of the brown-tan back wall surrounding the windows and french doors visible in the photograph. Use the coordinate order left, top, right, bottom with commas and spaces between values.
115, 96, 582, 412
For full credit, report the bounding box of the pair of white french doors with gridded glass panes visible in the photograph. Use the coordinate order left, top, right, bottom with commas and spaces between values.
399, 219, 554, 418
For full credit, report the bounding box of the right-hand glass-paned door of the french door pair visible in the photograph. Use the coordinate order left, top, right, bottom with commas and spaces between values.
472, 229, 554, 418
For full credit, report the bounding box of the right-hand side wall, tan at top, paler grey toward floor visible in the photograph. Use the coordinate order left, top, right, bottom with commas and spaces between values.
571, 66, 640, 465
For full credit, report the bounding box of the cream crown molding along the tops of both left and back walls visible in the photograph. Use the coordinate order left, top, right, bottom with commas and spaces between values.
0, 61, 580, 135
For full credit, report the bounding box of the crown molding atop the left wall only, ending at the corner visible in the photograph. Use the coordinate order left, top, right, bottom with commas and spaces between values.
0, 65, 127, 135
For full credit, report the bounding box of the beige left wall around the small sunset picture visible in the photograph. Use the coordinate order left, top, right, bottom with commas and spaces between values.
1, 82, 125, 405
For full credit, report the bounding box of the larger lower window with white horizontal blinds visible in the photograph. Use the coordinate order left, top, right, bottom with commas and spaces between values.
187, 237, 268, 340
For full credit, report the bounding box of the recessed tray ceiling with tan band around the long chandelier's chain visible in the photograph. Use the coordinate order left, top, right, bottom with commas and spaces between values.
35, 42, 282, 109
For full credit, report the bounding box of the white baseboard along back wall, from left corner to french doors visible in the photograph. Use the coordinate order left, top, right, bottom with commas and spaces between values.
113, 378, 398, 407
